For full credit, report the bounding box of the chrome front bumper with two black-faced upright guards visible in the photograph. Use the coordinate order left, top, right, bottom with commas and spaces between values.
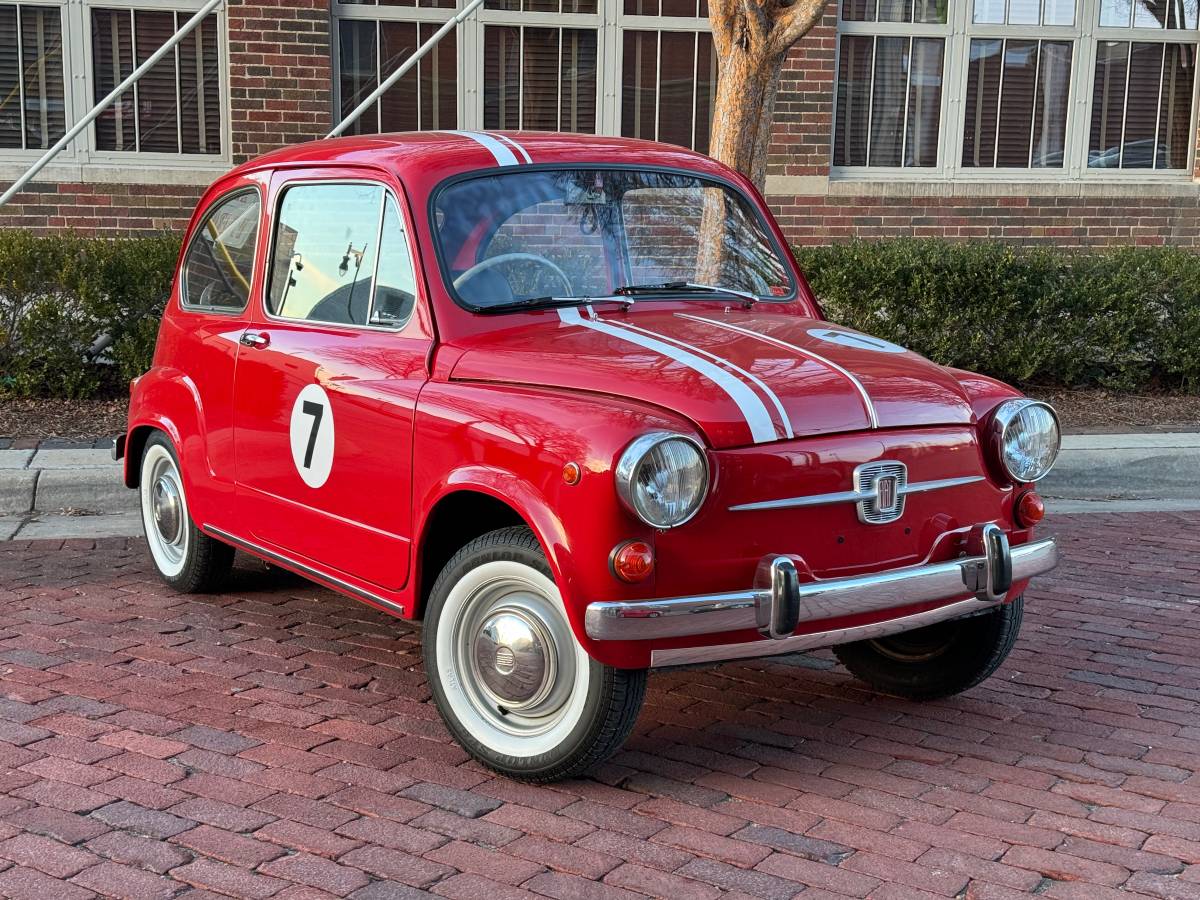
583, 532, 1058, 641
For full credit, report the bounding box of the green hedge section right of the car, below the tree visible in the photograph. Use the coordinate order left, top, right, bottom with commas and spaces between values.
797, 240, 1200, 391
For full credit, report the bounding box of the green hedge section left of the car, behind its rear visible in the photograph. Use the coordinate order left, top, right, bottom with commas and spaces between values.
0, 229, 179, 398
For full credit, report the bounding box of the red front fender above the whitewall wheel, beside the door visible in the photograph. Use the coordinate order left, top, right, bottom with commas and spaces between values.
413, 382, 695, 666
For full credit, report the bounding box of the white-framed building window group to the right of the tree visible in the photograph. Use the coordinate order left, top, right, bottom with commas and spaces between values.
832, 0, 1200, 178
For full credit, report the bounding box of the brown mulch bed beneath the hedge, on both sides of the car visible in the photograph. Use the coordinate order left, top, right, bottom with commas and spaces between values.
0, 388, 1200, 440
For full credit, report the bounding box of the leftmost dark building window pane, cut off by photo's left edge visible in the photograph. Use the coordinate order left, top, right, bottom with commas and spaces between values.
0, 2, 66, 150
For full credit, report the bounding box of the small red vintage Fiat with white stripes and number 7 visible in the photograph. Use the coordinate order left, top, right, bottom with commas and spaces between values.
116, 132, 1058, 781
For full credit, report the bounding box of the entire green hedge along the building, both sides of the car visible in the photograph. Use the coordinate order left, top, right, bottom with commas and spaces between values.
0, 229, 1200, 397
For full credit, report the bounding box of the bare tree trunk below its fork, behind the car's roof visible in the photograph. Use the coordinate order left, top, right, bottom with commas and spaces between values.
708, 43, 785, 191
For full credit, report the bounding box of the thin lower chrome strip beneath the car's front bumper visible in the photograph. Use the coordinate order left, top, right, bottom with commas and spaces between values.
650, 600, 1000, 668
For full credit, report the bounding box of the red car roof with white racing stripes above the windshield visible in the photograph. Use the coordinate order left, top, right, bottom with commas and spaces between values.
220, 131, 731, 185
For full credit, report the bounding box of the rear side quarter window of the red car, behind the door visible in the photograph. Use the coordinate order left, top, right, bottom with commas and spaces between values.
182, 190, 259, 312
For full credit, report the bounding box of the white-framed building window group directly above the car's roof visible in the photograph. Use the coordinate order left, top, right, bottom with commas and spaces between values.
334, 0, 716, 151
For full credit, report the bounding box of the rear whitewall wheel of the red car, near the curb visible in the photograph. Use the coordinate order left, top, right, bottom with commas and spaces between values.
139, 432, 234, 594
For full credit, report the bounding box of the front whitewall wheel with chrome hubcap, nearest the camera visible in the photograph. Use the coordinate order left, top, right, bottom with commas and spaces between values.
422, 528, 646, 782
